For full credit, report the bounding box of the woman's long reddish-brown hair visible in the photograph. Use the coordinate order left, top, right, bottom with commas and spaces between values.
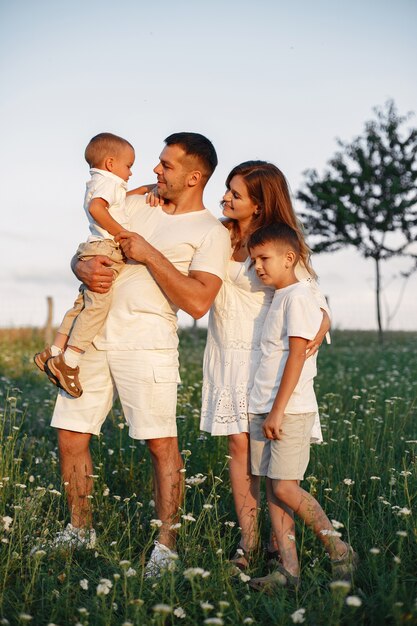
224, 161, 316, 277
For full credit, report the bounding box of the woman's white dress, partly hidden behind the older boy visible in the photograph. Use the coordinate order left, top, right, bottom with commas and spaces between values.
200, 258, 328, 441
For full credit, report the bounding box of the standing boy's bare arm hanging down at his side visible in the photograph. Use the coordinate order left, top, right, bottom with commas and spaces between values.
263, 337, 307, 439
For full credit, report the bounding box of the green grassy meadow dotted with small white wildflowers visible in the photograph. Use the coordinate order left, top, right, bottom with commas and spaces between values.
0, 330, 417, 626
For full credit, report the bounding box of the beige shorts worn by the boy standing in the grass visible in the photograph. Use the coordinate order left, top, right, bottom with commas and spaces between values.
249, 413, 316, 480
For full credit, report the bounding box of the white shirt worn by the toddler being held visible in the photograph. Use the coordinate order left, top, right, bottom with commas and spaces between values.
84, 168, 129, 241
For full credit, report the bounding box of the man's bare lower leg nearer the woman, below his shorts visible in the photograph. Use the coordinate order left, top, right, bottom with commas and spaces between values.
147, 437, 184, 548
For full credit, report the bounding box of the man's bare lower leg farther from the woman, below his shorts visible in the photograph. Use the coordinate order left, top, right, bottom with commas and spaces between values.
58, 429, 93, 528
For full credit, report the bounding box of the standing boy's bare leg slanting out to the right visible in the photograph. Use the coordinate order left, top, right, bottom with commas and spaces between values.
272, 479, 346, 559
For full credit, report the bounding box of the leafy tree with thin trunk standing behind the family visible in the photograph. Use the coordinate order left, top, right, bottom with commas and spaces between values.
297, 100, 417, 341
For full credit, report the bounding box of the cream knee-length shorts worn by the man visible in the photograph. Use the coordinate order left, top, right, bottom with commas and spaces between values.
51, 346, 180, 439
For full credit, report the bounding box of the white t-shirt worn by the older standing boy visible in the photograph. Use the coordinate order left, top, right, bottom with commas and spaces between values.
249, 283, 323, 413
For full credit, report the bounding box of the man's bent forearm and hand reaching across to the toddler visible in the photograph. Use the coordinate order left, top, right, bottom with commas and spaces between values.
115, 233, 222, 319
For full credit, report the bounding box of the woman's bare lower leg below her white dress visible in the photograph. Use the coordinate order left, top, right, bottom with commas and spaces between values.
228, 433, 260, 558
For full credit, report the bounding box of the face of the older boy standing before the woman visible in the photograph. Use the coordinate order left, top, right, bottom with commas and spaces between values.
250, 242, 296, 289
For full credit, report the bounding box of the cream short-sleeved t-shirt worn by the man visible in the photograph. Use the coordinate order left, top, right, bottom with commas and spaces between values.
94, 195, 231, 350
